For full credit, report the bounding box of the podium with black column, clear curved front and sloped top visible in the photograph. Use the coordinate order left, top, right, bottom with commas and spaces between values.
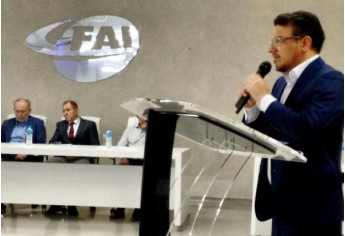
121, 98, 307, 236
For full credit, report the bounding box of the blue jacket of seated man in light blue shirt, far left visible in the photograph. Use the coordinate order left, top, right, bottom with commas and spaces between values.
1, 116, 47, 161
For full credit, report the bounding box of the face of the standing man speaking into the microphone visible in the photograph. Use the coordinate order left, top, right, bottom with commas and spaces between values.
269, 25, 303, 73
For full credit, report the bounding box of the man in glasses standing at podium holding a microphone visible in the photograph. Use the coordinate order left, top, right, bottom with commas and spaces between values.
240, 11, 344, 236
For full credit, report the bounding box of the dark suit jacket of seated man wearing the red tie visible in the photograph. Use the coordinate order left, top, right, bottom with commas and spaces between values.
49, 118, 100, 161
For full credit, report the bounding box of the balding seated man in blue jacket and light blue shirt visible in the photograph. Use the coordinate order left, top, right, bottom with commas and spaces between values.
1, 98, 46, 213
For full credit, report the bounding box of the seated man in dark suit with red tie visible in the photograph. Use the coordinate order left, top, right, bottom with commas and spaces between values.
46, 100, 100, 216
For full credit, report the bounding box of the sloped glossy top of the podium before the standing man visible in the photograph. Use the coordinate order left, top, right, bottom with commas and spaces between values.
121, 98, 307, 162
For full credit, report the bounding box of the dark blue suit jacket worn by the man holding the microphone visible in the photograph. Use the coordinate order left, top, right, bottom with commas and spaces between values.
249, 58, 344, 223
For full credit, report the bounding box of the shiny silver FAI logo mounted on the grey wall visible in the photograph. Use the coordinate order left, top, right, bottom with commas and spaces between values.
26, 16, 139, 82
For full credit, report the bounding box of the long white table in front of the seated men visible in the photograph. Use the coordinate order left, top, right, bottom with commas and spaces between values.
1, 143, 190, 227
